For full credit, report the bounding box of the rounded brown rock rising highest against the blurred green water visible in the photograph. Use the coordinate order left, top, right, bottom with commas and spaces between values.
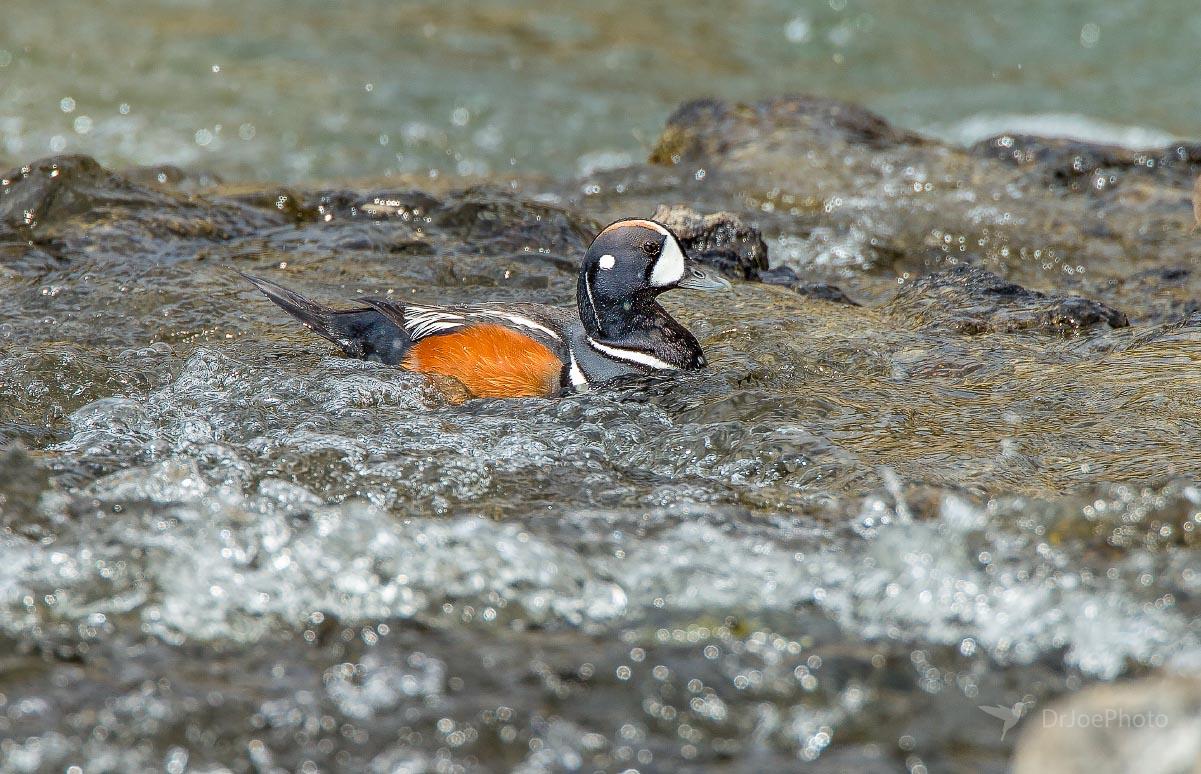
650, 95, 926, 163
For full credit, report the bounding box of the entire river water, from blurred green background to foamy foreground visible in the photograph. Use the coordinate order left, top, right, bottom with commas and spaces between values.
0, 0, 1201, 774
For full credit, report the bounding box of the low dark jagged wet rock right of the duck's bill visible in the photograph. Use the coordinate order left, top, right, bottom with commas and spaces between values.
886, 266, 1129, 335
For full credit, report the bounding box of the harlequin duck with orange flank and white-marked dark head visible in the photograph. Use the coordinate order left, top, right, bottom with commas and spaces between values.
243, 219, 730, 398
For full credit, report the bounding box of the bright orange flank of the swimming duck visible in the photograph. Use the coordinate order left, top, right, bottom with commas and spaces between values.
401, 325, 563, 398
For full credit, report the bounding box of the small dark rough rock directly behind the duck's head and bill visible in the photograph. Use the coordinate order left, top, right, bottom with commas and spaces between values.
651, 204, 767, 280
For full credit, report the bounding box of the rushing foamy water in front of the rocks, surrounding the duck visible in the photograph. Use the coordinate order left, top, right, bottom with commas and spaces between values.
0, 143, 1201, 772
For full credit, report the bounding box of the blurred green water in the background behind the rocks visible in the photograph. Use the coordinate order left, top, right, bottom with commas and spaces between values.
0, 0, 1201, 181
